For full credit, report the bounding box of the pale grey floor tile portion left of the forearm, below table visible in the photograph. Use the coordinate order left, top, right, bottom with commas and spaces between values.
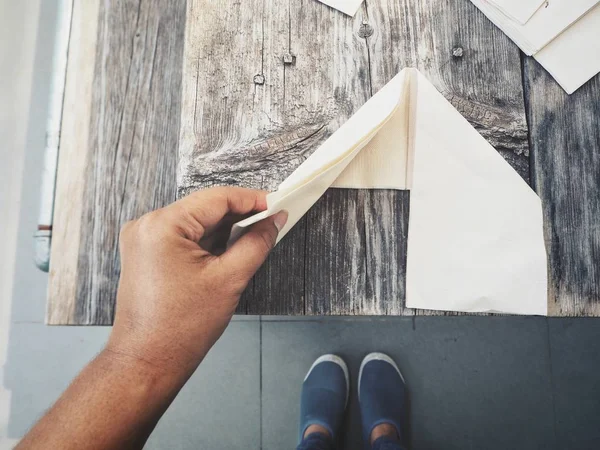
4, 323, 110, 438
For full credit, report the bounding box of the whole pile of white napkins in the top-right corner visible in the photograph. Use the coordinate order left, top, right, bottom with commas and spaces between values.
471, 0, 600, 94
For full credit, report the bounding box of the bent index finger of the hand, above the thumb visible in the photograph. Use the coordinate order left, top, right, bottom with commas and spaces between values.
167, 187, 267, 241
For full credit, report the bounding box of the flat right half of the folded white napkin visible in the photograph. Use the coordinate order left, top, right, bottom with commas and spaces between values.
406, 75, 547, 315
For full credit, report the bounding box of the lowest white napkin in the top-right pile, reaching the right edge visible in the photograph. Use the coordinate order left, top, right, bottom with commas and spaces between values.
534, 5, 600, 94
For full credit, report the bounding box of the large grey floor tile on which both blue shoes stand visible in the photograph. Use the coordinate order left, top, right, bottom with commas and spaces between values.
262, 317, 556, 450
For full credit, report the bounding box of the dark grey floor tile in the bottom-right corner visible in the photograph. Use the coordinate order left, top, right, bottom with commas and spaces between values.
548, 318, 600, 450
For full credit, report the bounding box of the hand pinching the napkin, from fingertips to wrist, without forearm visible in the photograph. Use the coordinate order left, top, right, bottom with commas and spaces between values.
106, 187, 287, 379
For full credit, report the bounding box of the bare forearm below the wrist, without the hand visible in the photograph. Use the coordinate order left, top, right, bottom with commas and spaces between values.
17, 350, 189, 449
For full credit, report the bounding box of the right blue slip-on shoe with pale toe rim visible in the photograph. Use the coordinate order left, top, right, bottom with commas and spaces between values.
358, 353, 406, 448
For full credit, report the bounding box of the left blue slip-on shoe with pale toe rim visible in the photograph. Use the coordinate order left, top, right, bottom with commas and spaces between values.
299, 355, 350, 442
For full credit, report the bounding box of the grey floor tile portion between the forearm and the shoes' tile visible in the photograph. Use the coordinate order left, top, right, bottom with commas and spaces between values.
147, 321, 260, 450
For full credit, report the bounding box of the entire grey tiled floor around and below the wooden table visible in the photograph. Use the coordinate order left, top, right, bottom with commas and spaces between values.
5, 1, 600, 450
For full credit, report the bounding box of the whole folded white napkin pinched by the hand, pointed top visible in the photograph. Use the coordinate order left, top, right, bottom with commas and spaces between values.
231, 69, 547, 315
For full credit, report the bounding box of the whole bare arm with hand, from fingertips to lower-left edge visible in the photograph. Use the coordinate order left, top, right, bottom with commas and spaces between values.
18, 188, 287, 449
